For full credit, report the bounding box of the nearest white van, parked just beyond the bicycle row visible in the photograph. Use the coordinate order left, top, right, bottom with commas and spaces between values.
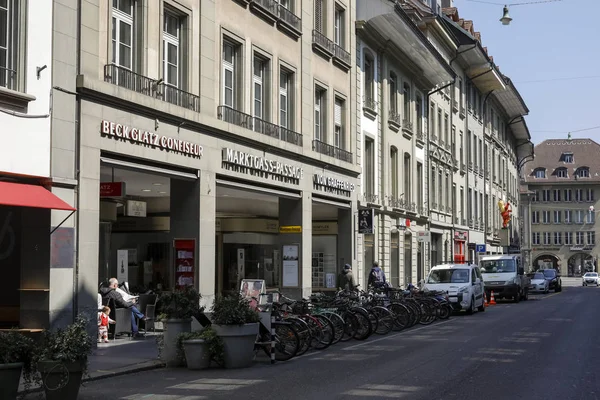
425, 264, 485, 314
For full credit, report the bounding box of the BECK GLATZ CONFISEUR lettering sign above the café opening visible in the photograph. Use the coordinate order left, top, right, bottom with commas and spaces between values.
100, 120, 204, 158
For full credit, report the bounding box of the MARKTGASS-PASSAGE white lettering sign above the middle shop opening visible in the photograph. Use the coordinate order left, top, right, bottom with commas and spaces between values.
222, 148, 304, 182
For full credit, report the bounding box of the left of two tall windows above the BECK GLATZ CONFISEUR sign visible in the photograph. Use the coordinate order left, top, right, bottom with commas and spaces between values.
112, 0, 135, 70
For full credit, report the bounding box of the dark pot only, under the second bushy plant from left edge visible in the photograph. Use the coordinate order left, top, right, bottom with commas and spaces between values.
37, 361, 83, 400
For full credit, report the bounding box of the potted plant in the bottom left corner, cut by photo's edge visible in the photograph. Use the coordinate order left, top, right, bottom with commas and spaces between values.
0, 330, 35, 399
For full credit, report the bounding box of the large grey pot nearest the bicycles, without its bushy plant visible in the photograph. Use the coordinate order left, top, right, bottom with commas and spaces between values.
213, 322, 258, 368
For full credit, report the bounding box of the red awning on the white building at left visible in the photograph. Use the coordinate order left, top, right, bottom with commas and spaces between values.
0, 182, 75, 211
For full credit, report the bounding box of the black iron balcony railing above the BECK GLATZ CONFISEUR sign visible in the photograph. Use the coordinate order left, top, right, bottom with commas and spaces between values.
104, 64, 200, 112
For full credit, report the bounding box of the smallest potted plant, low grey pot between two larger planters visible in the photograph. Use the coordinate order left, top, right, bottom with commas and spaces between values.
177, 326, 223, 370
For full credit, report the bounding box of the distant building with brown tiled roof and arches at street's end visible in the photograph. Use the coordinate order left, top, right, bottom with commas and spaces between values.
521, 138, 600, 276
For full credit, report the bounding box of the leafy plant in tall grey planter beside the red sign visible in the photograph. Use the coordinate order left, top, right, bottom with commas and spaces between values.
158, 286, 204, 367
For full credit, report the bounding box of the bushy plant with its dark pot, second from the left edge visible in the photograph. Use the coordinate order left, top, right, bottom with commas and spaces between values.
36, 315, 93, 400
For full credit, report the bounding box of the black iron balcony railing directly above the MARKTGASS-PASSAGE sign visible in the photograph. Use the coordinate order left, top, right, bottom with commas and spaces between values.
217, 106, 302, 146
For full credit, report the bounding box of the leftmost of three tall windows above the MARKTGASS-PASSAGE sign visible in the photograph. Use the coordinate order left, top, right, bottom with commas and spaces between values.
221, 38, 242, 111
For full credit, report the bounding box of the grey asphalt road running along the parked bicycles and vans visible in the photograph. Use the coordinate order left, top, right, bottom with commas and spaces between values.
52, 287, 600, 400
